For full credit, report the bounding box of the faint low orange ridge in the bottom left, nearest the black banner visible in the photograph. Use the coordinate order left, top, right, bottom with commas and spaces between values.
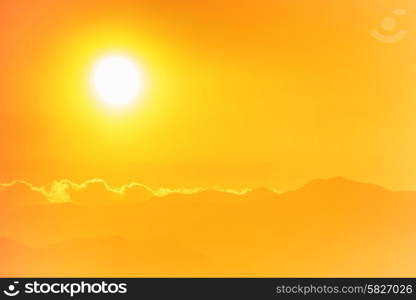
0, 237, 209, 276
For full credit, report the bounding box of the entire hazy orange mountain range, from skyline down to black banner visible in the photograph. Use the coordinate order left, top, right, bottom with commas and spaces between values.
0, 177, 416, 276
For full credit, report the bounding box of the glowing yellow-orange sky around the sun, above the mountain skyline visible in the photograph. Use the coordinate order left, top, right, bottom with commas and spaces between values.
0, 0, 416, 190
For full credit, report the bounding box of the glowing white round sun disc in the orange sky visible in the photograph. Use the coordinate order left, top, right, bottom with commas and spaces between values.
92, 54, 143, 108
